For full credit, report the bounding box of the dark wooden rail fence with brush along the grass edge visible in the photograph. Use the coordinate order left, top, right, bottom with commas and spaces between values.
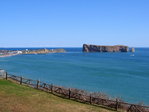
1, 73, 149, 112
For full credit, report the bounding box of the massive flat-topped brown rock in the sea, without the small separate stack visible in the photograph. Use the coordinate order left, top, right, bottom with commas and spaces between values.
83, 44, 129, 52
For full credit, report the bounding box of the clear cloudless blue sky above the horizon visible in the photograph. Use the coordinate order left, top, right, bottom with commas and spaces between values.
0, 0, 149, 47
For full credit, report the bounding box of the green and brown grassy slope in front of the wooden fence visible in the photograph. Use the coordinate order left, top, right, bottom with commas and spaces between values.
0, 79, 115, 112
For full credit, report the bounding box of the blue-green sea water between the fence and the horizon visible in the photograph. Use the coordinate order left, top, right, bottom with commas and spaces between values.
0, 48, 149, 105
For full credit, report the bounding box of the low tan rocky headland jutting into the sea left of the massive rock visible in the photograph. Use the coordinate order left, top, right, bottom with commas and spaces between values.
22, 49, 66, 54
